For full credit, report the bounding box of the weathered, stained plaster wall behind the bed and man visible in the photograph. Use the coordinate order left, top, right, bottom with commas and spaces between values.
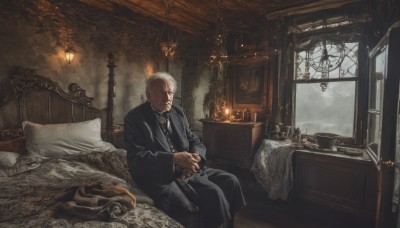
0, 0, 208, 128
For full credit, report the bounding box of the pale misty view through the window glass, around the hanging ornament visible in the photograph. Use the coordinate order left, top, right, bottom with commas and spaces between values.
294, 42, 358, 137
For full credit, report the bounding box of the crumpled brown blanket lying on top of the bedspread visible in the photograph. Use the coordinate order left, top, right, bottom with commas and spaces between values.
56, 182, 136, 221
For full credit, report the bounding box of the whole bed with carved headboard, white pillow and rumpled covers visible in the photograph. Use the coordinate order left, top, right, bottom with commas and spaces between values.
0, 58, 182, 227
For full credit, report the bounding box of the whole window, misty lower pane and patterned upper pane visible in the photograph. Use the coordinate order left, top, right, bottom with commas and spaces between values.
293, 38, 359, 138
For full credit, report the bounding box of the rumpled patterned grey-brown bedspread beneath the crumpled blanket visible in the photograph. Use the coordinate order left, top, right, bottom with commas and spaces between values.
0, 150, 182, 227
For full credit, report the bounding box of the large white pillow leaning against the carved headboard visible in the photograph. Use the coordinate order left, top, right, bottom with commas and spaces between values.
22, 118, 115, 157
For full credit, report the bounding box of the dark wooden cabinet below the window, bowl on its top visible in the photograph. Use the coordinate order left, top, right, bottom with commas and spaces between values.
294, 150, 377, 220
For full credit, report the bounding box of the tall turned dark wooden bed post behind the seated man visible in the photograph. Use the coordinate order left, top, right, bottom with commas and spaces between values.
106, 53, 117, 143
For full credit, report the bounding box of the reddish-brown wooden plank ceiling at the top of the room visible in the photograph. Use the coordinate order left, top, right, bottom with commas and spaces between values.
80, 0, 361, 36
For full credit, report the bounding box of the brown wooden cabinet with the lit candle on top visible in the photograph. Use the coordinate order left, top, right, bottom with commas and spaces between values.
201, 120, 264, 169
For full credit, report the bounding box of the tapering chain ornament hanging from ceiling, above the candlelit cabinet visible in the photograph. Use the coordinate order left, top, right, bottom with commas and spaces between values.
210, 0, 228, 65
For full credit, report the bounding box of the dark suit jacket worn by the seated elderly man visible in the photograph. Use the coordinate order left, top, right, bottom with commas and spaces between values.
124, 102, 206, 200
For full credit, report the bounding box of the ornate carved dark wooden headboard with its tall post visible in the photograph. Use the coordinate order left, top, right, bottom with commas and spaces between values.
0, 54, 116, 142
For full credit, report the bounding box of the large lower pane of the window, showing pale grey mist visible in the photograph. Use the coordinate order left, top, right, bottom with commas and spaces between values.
295, 81, 356, 137
